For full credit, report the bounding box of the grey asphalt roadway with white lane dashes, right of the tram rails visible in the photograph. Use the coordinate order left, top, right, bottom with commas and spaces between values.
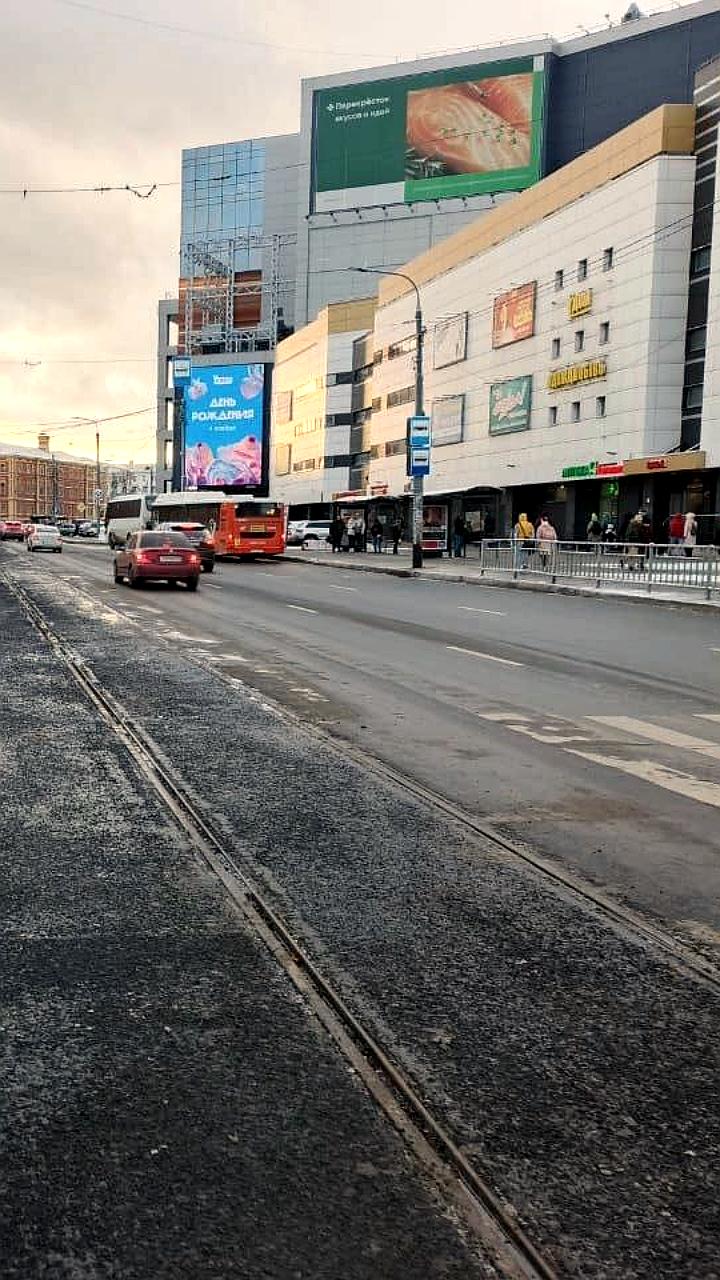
4, 532, 720, 948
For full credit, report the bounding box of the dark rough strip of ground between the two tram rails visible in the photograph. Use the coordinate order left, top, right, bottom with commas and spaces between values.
12, 579, 720, 1280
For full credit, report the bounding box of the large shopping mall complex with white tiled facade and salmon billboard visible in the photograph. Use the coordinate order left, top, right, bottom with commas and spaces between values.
159, 0, 720, 535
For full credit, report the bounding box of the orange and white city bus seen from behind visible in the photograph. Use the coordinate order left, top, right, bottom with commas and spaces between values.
152, 490, 286, 556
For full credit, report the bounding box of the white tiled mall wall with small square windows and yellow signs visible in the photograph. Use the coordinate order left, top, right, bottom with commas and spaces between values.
370, 155, 691, 494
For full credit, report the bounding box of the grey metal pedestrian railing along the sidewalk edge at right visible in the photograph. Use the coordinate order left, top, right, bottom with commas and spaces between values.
468, 538, 720, 600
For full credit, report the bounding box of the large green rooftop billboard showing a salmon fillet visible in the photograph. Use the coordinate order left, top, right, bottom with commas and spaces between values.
313, 56, 544, 212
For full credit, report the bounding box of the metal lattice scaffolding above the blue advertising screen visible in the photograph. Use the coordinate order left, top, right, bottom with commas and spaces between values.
178, 233, 297, 356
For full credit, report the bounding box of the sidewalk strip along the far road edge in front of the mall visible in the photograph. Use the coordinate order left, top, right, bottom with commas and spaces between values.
284, 548, 720, 609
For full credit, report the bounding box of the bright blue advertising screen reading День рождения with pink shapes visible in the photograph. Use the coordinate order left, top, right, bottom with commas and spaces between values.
183, 365, 265, 489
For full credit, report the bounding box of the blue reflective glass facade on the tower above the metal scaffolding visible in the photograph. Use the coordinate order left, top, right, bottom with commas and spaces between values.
181, 141, 265, 274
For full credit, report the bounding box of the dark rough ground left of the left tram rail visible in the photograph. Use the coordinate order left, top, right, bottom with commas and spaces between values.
0, 584, 496, 1280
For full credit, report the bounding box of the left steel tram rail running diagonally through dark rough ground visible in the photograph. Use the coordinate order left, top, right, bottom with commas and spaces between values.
0, 572, 558, 1280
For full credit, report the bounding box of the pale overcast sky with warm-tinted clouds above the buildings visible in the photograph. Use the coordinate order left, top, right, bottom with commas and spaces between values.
0, 0, 667, 461
